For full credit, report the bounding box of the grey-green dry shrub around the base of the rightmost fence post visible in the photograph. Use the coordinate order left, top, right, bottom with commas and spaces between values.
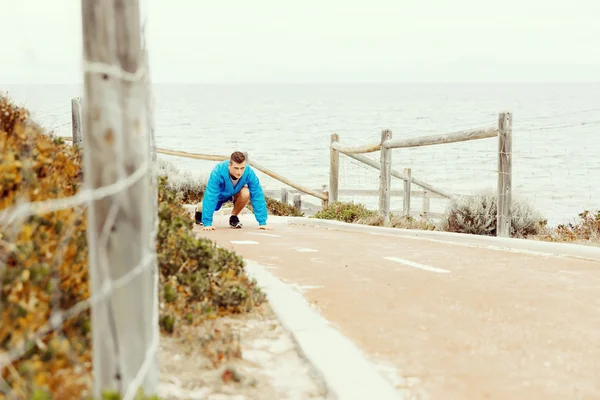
442, 189, 546, 237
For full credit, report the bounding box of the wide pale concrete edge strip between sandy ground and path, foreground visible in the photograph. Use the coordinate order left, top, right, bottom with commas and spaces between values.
245, 259, 402, 400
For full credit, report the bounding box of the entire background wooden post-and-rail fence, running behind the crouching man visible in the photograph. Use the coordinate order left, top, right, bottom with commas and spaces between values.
69, 98, 512, 237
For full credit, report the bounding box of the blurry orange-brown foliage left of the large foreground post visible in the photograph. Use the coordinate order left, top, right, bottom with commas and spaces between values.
0, 97, 91, 398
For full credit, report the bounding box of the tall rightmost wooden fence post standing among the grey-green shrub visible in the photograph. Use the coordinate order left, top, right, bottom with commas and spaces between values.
496, 113, 512, 237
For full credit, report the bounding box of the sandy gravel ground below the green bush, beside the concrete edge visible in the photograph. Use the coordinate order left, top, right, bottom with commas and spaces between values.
159, 304, 328, 400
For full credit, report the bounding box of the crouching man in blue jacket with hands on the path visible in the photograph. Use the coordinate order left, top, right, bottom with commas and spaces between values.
195, 151, 271, 231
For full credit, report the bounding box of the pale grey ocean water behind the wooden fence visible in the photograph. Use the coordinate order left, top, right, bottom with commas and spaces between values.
0, 83, 600, 224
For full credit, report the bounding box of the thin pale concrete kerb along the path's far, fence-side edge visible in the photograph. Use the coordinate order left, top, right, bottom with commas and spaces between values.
287, 217, 600, 261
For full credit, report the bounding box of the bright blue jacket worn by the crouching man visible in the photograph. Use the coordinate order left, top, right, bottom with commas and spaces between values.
202, 160, 267, 226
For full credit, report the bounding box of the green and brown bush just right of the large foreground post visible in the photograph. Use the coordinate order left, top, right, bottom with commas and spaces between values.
156, 176, 265, 332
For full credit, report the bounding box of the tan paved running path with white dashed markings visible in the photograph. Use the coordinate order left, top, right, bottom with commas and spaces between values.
195, 215, 600, 400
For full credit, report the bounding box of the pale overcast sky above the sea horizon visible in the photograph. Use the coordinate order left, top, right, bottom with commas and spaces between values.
0, 0, 600, 83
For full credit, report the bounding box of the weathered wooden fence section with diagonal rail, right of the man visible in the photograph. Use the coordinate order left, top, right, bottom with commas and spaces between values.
329, 113, 512, 237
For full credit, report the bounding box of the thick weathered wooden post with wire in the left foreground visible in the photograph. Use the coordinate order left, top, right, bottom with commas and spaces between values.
81, 0, 158, 398
